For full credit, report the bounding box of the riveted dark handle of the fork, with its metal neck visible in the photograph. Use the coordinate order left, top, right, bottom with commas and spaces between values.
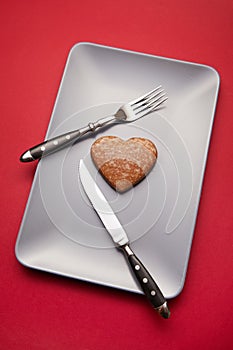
20, 116, 115, 163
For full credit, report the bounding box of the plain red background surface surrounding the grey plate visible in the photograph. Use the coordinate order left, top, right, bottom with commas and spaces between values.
0, 0, 233, 350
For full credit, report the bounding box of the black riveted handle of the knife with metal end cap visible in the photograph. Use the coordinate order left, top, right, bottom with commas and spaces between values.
120, 244, 170, 318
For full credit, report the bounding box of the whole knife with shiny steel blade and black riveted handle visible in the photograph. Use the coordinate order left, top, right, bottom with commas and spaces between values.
79, 159, 170, 318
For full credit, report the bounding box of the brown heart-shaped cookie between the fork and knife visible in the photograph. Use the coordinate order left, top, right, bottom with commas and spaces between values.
91, 136, 158, 192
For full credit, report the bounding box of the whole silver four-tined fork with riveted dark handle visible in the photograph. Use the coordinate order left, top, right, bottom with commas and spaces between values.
20, 85, 168, 162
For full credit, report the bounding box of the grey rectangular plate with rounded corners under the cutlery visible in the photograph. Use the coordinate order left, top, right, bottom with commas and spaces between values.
16, 43, 219, 298
